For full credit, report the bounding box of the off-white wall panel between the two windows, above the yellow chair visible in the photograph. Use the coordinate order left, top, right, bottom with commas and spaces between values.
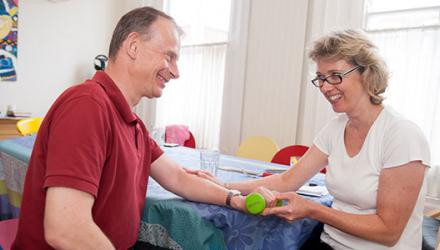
241, 0, 308, 146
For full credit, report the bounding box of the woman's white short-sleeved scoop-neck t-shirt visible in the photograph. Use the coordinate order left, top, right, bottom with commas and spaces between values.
314, 107, 430, 250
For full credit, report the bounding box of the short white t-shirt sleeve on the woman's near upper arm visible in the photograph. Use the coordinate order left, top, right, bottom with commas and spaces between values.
382, 120, 430, 168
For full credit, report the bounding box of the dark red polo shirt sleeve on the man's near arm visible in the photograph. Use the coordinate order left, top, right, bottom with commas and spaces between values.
44, 95, 109, 197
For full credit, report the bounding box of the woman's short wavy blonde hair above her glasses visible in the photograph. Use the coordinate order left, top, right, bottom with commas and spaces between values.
309, 29, 389, 105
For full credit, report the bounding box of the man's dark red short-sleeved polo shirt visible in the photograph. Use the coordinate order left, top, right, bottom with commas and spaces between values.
13, 71, 163, 249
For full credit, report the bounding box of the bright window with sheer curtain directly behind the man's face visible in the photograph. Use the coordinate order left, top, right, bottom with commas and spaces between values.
155, 0, 231, 148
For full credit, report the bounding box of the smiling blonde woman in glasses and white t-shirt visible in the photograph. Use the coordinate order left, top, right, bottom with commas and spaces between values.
195, 30, 430, 250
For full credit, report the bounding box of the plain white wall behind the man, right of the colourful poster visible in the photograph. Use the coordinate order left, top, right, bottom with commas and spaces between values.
0, 0, 139, 116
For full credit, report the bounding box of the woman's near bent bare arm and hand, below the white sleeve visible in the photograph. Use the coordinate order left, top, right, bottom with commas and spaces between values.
264, 161, 426, 246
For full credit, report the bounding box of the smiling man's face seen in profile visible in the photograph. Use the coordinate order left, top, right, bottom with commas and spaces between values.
132, 17, 180, 98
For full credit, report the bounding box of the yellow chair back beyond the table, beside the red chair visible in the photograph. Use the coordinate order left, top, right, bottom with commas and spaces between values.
235, 136, 278, 162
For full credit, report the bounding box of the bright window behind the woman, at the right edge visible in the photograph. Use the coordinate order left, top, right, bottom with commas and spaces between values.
364, 0, 440, 165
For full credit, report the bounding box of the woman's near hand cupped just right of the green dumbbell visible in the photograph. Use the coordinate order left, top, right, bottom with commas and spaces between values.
262, 192, 310, 222
